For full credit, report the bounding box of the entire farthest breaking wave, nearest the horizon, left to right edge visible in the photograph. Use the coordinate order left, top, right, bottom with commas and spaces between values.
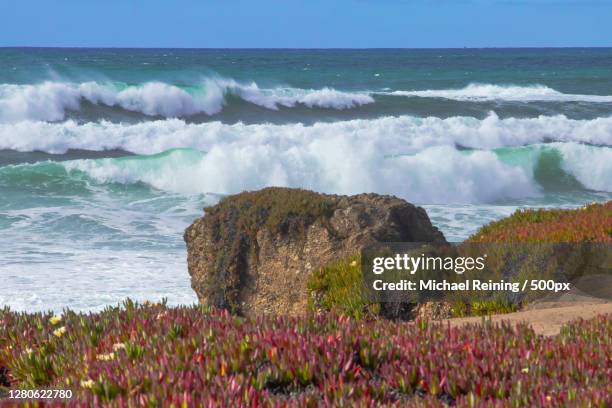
0, 77, 612, 123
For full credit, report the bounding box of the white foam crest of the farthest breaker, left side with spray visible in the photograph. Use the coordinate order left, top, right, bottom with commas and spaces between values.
0, 77, 374, 123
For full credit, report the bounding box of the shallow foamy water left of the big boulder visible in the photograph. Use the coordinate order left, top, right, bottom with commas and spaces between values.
0, 188, 206, 312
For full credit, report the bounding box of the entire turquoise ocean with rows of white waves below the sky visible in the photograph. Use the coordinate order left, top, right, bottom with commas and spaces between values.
0, 48, 612, 311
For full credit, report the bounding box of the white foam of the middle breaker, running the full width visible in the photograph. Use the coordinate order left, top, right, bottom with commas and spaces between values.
0, 114, 612, 155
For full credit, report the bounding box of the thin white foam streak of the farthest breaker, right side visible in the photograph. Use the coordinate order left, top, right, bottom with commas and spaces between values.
381, 84, 612, 103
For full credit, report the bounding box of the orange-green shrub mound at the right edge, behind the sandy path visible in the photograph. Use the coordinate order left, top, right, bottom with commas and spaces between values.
460, 201, 612, 307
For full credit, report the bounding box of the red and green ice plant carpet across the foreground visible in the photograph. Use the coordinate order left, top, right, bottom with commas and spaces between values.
0, 301, 612, 407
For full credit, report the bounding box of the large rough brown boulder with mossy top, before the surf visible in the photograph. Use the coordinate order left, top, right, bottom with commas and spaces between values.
184, 188, 446, 315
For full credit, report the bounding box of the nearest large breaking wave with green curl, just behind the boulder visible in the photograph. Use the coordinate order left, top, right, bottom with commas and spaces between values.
0, 139, 612, 204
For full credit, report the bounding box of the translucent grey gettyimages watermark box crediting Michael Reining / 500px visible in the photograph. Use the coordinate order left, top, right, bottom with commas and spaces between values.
362, 243, 612, 302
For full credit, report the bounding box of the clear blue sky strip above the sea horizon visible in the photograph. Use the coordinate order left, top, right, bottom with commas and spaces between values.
0, 0, 612, 48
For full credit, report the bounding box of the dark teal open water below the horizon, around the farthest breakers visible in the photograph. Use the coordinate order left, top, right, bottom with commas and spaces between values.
0, 49, 612, 123
